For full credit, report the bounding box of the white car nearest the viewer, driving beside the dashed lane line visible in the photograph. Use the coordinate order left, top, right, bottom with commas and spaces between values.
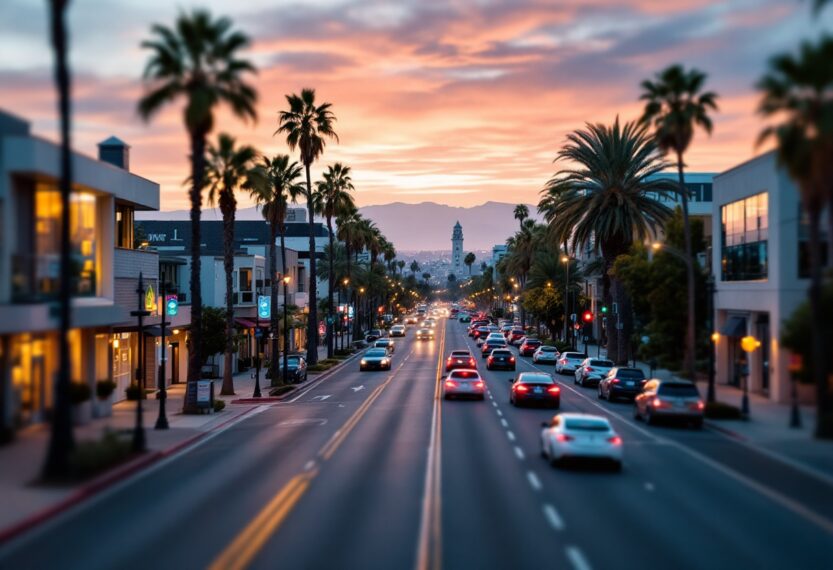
541, 413, 622, 471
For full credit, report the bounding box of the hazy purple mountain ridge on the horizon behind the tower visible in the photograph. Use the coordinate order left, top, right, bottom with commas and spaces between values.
136, 202, 535, 252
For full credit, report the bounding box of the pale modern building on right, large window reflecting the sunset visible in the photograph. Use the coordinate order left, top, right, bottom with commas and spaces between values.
712, 152, 826, 402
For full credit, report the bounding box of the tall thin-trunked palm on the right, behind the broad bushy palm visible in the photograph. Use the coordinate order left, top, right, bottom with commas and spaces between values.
640, 65, 717, 380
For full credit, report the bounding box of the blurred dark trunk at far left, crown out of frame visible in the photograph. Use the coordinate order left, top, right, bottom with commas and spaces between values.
43, 0, 75, 479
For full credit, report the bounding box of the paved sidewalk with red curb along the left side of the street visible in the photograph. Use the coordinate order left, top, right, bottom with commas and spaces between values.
0, 366, 260, 541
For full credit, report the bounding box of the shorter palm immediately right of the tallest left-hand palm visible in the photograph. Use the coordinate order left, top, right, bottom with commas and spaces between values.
205, 133, 260, 396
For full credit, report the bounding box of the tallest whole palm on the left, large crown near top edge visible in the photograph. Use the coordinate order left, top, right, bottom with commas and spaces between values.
139, 10, 257, 402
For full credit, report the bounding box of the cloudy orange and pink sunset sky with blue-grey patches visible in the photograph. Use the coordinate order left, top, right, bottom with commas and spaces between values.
0, 0, 833, 210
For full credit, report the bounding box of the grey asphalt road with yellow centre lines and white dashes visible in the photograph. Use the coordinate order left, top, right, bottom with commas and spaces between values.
0, 322, 833, 570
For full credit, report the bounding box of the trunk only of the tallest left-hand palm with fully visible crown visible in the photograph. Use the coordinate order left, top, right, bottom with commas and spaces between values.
182, 130, 205, 413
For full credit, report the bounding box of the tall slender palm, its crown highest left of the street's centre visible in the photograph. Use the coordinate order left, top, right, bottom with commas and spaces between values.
275, 89, 338, 364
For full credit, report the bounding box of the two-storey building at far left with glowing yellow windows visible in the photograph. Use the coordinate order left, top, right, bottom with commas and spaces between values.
0, 111, 159, 429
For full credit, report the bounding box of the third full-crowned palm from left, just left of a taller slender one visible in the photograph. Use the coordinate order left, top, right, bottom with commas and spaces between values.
252, 154, 304, 385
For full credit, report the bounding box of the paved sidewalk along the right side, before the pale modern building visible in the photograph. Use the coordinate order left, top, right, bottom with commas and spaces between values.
612, 352, 833, 480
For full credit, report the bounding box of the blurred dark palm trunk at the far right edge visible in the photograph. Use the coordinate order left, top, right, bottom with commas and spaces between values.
807, 208, 833, 439
